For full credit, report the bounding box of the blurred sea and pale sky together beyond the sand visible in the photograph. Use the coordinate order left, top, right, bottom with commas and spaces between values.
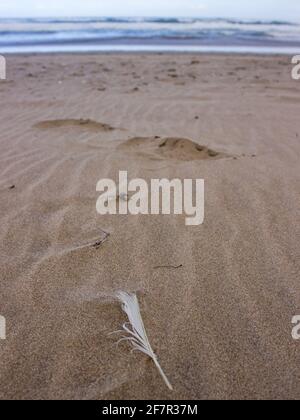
0, 0, 300, 54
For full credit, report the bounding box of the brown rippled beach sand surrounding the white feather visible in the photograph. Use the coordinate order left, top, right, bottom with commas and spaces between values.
0, 54, 300, 400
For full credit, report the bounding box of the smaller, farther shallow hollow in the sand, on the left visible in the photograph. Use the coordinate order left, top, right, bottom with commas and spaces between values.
34, 119, 115, 132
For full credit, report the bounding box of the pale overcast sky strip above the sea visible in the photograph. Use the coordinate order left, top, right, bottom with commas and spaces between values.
0, 0, 300, 21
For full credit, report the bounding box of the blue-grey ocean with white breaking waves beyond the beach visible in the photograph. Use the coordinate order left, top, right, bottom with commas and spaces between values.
0, 18, 300, 54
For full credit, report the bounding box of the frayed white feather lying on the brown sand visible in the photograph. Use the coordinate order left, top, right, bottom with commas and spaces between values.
116, 291, 173, 391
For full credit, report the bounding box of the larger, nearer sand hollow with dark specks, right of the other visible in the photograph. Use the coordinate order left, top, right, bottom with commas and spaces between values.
119, 136, 228, 161
